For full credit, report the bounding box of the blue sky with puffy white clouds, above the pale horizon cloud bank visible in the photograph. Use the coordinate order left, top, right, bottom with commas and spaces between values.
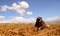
0, 0, 60, 20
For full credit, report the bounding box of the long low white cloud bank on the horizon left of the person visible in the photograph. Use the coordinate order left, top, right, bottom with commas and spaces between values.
0, 17, 35, 23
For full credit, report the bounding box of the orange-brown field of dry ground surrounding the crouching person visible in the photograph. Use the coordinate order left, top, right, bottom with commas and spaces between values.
0, 23, 60, 36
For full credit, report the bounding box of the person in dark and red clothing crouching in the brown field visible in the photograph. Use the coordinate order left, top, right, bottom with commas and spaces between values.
35, 17, 46, 30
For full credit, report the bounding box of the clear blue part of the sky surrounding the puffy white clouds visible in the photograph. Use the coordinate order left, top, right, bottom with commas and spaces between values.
0, 0, 60, 19
